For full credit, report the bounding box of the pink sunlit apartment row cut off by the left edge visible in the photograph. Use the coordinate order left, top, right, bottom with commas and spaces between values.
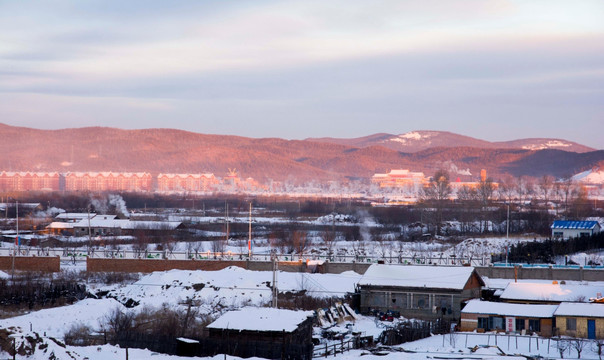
0, 171, 61, 191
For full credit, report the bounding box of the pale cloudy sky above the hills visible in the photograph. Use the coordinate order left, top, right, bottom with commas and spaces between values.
0, 0, 604, 149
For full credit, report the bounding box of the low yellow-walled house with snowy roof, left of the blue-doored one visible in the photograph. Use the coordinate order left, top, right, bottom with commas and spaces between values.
461, 299, 558, 336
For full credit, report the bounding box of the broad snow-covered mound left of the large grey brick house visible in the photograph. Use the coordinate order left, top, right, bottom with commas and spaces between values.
98, 266, 361, 313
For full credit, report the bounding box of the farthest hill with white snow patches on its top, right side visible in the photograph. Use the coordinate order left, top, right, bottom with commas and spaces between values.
306, 130, 595, 153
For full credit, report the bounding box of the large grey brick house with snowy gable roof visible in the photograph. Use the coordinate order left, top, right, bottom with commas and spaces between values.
358, 264, 484, 319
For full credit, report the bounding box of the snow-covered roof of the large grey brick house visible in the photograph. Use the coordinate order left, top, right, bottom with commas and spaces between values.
359, 264, 474, 290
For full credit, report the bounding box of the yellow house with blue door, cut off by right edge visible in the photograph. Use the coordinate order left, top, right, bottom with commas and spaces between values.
554, 303, 604, 339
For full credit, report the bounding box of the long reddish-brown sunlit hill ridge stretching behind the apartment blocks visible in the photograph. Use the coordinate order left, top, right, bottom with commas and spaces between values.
0, 124, 604, 182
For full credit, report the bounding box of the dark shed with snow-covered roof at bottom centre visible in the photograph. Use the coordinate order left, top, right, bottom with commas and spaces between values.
205, 307, 314, 360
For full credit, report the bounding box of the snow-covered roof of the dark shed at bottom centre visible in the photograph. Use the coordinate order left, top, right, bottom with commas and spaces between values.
208, 307, 314, 332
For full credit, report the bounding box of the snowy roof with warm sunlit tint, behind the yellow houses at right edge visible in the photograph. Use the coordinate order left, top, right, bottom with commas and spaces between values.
501, 282, 604, 302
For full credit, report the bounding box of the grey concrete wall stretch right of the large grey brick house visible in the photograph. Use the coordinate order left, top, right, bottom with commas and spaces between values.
476, 266, 604, 281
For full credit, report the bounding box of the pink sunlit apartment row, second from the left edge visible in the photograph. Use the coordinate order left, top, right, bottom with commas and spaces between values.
64, 172, 152, 191
